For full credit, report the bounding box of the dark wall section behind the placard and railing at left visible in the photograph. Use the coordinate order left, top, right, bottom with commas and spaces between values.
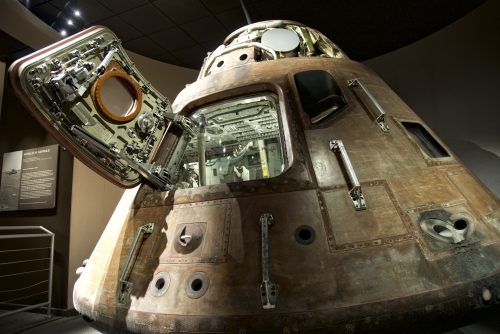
0, 72, 73, 309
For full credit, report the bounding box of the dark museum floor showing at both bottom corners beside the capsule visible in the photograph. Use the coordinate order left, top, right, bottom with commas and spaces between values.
0, 312, 500, 334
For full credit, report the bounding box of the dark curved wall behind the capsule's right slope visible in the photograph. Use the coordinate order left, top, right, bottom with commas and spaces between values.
365, 0, 500, 197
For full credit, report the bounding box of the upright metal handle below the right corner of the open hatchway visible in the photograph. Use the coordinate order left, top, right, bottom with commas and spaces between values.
259, 213, 278, 309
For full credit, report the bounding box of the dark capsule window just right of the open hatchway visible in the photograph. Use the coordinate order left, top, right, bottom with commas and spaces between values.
294, 70, 347, 123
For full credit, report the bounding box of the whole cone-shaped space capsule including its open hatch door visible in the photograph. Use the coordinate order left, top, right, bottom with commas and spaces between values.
10, 21, 500, 333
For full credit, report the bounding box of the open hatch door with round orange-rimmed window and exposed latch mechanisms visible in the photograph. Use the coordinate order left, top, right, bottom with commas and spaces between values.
9, 26, 190, 190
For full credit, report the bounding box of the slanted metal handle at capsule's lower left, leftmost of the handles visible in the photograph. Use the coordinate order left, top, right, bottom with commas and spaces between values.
118, 223, 154, 304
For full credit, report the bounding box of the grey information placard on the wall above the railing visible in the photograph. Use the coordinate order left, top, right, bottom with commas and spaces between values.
0, 145, 59, 211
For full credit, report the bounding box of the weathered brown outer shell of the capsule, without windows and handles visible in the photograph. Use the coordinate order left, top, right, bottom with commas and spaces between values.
75, 58, 500, 333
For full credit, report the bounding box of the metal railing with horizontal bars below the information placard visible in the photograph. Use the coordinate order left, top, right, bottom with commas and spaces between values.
0, 226, 54, 319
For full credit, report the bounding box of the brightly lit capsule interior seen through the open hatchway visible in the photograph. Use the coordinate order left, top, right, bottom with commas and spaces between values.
178, 94, 285, 188
